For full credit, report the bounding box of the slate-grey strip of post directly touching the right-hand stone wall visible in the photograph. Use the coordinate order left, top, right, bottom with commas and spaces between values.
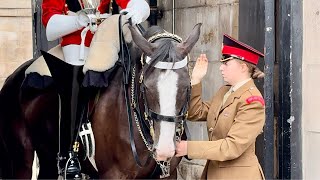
289, 0, 303, 179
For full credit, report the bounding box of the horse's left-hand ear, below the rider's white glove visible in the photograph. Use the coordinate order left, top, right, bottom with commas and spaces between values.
129, 25, 155, 56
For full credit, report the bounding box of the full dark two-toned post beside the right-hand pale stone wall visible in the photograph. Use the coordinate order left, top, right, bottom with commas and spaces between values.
277, 0, 302, 179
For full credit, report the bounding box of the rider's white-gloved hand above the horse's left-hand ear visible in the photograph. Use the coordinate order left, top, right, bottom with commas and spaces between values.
120, 0, 150, 25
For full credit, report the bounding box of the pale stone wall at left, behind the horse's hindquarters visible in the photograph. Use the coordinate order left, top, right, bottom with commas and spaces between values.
0, 0, 33, 88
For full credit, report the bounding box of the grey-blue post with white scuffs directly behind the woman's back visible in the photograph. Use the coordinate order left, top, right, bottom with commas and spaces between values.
262, 0, 275, 179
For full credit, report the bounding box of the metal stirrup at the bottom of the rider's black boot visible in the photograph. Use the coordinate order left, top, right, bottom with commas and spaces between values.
64, 151, 81, 179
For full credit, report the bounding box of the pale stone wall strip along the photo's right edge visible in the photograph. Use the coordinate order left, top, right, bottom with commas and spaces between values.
302, 0, 320, 179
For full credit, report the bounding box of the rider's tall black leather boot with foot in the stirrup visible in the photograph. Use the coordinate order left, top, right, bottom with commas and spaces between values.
41, 51, 83, 179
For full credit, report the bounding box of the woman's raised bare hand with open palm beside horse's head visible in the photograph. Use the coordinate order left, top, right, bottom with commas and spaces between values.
191, 54, 208, 85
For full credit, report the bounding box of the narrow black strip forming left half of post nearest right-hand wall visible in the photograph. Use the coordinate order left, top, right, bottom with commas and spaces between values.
278, 1, 291, 179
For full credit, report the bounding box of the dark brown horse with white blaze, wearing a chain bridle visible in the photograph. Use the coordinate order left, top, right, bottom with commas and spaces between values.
0, 21, 201, 179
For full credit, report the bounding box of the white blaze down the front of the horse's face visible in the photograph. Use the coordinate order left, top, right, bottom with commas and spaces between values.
156, 70, 179, 157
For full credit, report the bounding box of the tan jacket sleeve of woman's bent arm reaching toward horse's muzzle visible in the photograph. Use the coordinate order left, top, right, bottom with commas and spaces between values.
187, 101, 265, 161
